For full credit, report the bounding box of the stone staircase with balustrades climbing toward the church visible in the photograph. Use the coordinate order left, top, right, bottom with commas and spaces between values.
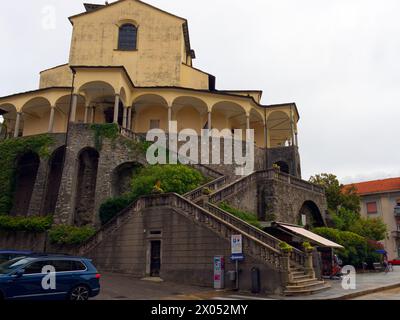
79, 129, 328, 295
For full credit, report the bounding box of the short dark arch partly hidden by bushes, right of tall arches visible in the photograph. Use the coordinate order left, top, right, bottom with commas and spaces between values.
111, 162, 143, 197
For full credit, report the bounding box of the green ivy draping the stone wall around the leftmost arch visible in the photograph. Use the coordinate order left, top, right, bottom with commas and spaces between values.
0, 134, 55, 216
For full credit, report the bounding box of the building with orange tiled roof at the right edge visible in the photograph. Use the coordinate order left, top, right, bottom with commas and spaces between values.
346, 178, 400, 259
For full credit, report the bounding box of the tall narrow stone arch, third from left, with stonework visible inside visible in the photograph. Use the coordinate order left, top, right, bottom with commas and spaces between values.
74, 148, 100, 226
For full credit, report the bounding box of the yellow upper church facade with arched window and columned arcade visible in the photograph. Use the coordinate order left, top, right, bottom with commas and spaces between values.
0, 0, 299, 148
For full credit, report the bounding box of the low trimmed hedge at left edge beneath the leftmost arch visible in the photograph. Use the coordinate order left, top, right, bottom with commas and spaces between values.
0, 216, 53, 233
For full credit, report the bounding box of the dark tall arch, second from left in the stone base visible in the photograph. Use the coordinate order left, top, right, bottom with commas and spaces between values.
42, 146, 66, 216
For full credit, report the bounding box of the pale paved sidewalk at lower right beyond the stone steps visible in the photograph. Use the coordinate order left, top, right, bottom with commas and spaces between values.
274, 266, 400, 300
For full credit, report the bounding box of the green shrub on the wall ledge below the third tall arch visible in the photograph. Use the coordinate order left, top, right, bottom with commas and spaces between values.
49, 225, 96, 245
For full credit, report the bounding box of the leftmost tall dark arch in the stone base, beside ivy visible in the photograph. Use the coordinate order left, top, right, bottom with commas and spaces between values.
11, 151, 40, 216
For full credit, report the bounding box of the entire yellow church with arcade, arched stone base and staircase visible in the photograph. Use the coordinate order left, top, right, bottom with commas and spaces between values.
0, 0, 327, 293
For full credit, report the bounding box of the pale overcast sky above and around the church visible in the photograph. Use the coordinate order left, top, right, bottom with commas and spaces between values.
0, 0, 400, 182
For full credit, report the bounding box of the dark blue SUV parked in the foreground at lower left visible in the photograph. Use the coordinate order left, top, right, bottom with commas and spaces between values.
0, 255, 100, 300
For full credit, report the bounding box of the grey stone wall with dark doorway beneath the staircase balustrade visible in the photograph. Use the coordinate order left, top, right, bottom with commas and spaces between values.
89, 207, 281, 293
